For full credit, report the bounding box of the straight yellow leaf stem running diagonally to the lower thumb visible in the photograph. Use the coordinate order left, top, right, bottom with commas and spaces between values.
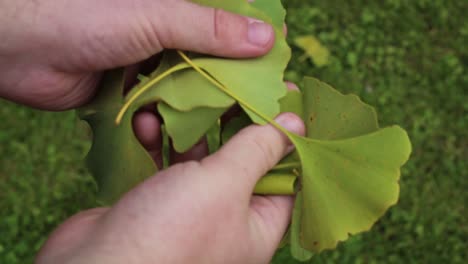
177, 50, 291, 137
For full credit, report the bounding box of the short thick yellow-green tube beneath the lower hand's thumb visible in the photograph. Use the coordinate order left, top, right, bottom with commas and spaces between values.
254, 173, 298, 195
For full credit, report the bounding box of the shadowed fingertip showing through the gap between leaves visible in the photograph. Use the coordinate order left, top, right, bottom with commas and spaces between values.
133, 111, 163, 168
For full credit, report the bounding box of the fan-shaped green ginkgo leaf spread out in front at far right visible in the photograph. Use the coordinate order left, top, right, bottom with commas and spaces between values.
291, 126, 411, 252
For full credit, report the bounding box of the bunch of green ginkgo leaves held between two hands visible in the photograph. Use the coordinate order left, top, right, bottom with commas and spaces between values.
79, 0, 411, 260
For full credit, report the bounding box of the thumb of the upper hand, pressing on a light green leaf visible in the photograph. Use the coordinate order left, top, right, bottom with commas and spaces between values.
155, 1, 274, 57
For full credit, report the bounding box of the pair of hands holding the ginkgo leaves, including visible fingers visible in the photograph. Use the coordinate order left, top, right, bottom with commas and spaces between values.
0, 0, 304, 263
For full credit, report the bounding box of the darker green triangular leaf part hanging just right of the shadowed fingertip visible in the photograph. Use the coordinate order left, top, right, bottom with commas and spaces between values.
158, 103, 227, 153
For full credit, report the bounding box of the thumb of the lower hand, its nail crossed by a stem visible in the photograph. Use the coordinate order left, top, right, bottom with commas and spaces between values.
201, 113, 305, 202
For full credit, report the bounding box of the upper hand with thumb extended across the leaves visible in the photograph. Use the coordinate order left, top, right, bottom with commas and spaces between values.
0, 0, 274, 110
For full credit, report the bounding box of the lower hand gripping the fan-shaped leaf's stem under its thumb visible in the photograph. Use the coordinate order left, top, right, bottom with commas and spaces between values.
37, 113, 304, 264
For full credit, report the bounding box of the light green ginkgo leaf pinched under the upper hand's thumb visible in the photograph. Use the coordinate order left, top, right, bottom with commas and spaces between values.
189, 0, 291, 124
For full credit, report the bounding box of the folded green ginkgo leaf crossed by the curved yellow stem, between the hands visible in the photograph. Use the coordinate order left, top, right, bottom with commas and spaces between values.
122, 51, 235, 153
